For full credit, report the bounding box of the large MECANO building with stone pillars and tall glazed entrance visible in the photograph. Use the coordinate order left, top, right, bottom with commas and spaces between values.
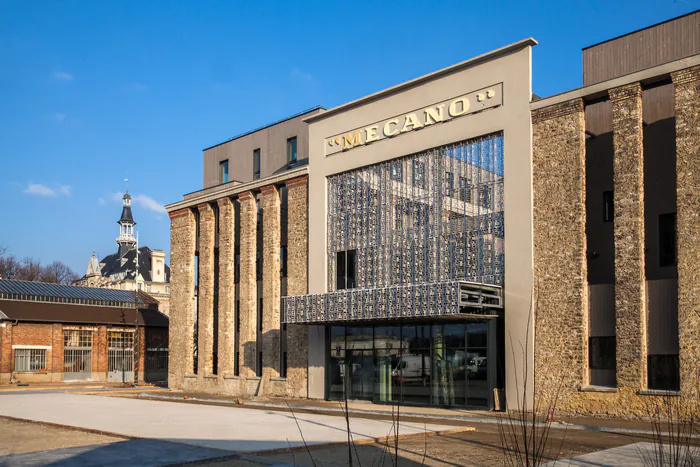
167, 12, 700, 415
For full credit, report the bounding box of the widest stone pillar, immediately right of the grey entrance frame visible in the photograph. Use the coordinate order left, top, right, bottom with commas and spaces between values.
532, 99, 588, 410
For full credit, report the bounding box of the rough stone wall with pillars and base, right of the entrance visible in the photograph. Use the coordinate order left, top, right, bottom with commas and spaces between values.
532, 67, 700, 418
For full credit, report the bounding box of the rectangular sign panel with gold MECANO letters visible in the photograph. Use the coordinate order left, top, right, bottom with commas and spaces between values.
326, 83, 503, 156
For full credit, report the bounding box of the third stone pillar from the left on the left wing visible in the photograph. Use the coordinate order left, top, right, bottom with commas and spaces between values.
217, 198, 236, 376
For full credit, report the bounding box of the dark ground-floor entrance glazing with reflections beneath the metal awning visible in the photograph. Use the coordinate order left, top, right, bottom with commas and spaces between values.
328, 323, 490, 407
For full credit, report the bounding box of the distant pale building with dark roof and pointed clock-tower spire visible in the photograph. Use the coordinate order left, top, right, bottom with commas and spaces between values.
75, 191, 170, 315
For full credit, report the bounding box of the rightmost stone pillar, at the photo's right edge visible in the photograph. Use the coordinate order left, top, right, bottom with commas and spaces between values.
671, 66, 700, 394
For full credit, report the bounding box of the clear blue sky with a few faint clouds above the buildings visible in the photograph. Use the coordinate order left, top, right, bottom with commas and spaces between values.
0, 0, 700, 274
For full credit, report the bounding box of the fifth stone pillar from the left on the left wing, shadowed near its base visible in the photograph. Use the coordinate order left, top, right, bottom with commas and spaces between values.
262, 185, 281, 378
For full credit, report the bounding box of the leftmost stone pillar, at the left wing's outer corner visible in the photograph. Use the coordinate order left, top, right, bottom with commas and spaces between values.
171, 209, 197, 382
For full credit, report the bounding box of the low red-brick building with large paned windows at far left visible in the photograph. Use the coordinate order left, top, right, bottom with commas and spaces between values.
0, 280, 168, 384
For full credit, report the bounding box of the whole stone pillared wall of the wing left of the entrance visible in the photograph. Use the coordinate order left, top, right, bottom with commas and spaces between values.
169, 176, 308, 398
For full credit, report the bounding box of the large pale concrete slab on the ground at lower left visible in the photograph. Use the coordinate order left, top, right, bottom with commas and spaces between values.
0, 393, 462, 452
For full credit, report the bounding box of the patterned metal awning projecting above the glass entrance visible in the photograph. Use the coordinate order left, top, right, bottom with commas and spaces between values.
282, 281, 503, 324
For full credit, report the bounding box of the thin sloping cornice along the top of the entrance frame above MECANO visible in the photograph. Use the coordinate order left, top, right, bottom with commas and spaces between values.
304, 37, 537, 123
